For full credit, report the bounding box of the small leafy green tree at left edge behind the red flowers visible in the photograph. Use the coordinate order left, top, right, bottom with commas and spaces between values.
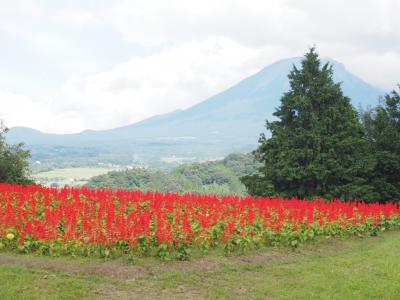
0, 123, 32, 184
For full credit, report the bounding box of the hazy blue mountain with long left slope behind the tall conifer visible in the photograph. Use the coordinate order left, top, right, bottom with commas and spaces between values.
7, 57, 385, 168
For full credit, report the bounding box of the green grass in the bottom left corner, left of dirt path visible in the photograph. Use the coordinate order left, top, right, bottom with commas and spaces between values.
0, 252, 155, 299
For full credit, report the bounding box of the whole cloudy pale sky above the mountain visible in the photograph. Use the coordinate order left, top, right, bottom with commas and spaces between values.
0, 0, 400, 133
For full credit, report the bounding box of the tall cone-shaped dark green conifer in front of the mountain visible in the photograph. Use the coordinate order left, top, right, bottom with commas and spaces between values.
242, 48, 373, 199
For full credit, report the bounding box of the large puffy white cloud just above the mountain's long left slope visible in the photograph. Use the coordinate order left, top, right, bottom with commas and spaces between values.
58, 39, 260, 134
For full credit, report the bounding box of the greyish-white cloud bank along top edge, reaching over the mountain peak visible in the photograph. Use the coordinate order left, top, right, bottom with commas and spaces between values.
104, 0, 400, 88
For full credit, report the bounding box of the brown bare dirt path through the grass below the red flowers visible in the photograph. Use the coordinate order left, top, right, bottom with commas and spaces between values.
0, 253, 302, 300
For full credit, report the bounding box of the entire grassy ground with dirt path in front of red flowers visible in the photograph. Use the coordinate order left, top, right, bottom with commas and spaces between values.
0, 231, 400, 299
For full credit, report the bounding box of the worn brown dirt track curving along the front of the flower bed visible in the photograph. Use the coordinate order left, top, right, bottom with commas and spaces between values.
0, 237, 379, 300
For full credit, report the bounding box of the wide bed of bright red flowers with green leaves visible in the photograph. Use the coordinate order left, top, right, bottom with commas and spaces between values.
0, 184, 400, 259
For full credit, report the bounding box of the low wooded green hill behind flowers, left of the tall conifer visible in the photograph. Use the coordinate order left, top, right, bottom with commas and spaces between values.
86, 154, 259, 195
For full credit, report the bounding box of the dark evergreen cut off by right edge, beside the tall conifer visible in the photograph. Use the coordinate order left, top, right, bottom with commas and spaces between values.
363, 85, 400, 201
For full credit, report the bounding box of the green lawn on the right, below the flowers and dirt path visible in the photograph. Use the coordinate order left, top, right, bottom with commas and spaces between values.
134, 232, 400, 299
